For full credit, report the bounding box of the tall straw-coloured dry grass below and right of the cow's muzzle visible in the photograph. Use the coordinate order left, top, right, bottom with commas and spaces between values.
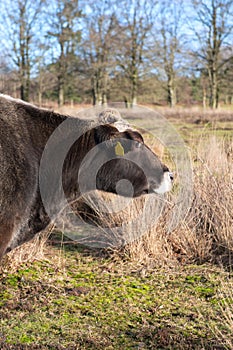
64, 136, 233, 265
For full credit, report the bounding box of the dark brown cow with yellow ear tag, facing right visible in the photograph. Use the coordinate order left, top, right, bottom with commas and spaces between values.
0, 95, 173, 259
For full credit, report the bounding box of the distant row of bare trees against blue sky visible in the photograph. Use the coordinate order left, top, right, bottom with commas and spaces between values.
0, 0, 233, 108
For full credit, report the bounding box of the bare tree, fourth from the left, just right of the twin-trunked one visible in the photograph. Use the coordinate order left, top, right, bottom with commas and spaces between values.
117, 0, 156, 106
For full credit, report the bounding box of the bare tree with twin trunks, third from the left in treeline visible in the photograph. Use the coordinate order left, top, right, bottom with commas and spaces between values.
83, 0, 118, 105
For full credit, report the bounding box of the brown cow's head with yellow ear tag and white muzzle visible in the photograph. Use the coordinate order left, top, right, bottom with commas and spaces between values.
90, 125, 173, 197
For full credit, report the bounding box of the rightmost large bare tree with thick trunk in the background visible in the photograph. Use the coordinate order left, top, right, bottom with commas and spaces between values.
192, 0, 233, 108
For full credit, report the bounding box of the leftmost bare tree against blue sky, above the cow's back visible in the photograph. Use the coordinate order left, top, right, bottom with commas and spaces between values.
1, 0, 44, 101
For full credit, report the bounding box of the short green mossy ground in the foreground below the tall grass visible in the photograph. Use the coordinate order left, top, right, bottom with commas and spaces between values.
0, 250, 231, 349
